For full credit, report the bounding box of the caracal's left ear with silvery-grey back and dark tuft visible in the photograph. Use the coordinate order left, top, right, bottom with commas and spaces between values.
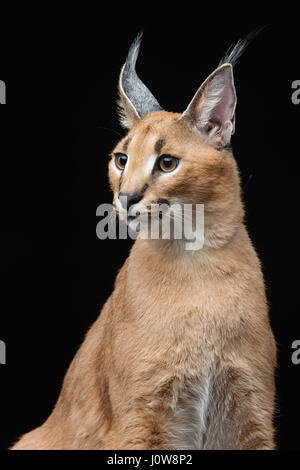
118, 34, 162, 128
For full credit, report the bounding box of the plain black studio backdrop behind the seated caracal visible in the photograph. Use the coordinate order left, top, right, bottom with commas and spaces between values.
0, 2, 300, 449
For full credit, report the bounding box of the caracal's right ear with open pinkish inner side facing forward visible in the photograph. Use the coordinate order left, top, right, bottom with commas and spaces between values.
179, 63, 236, 146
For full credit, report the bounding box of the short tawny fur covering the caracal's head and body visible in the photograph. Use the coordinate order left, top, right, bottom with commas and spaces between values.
13, 35, 276, 449
